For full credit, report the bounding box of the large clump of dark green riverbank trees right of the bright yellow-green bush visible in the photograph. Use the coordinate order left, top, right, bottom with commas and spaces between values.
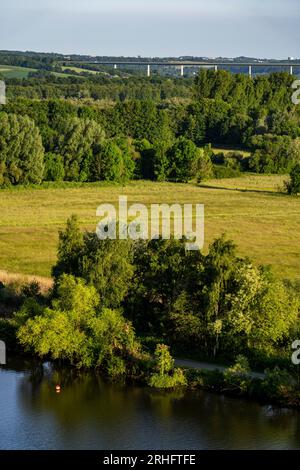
125, 237, 299, 359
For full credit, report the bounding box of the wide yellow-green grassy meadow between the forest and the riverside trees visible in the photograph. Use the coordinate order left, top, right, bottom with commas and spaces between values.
0, 175, 300, 279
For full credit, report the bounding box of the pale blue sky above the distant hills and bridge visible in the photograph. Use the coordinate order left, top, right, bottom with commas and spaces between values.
0, 0, 300, 59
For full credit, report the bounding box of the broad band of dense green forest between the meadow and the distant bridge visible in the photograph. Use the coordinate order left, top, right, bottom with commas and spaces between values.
0, 70, 300, 186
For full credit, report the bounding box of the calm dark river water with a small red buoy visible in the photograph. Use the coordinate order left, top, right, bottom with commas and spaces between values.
0, 360, 300, 450
